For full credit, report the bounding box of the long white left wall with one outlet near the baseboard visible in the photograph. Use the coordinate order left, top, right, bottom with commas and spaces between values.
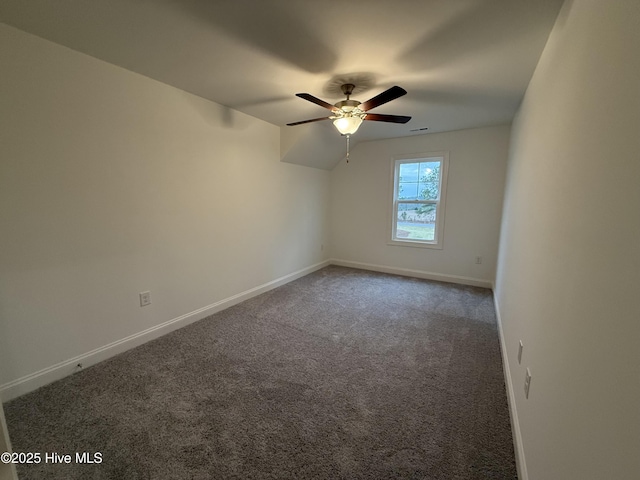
0, 24, 329, 398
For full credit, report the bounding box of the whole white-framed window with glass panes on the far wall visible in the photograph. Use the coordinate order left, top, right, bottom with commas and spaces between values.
390, 152, 449, 248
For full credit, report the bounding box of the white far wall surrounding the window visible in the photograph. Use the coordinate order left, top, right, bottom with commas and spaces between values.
330, 126, 509, 286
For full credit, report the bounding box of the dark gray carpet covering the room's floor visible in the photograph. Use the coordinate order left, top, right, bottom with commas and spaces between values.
5, 266, 517, 480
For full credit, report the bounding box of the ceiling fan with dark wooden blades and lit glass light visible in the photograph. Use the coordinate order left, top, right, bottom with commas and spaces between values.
287, 83, 411, 137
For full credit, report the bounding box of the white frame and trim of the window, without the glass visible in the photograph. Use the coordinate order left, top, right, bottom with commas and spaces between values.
387, 152, 449, 249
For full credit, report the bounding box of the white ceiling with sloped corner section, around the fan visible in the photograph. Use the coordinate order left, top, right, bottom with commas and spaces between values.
0, 0, 563, 169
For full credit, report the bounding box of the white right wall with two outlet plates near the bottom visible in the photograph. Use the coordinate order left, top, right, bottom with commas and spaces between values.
496, 0, 640, 480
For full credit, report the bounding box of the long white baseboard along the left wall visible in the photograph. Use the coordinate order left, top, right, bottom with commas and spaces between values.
0, 260, 330, 402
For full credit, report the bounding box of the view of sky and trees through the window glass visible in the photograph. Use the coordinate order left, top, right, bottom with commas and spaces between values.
395, 161, 441, 241
